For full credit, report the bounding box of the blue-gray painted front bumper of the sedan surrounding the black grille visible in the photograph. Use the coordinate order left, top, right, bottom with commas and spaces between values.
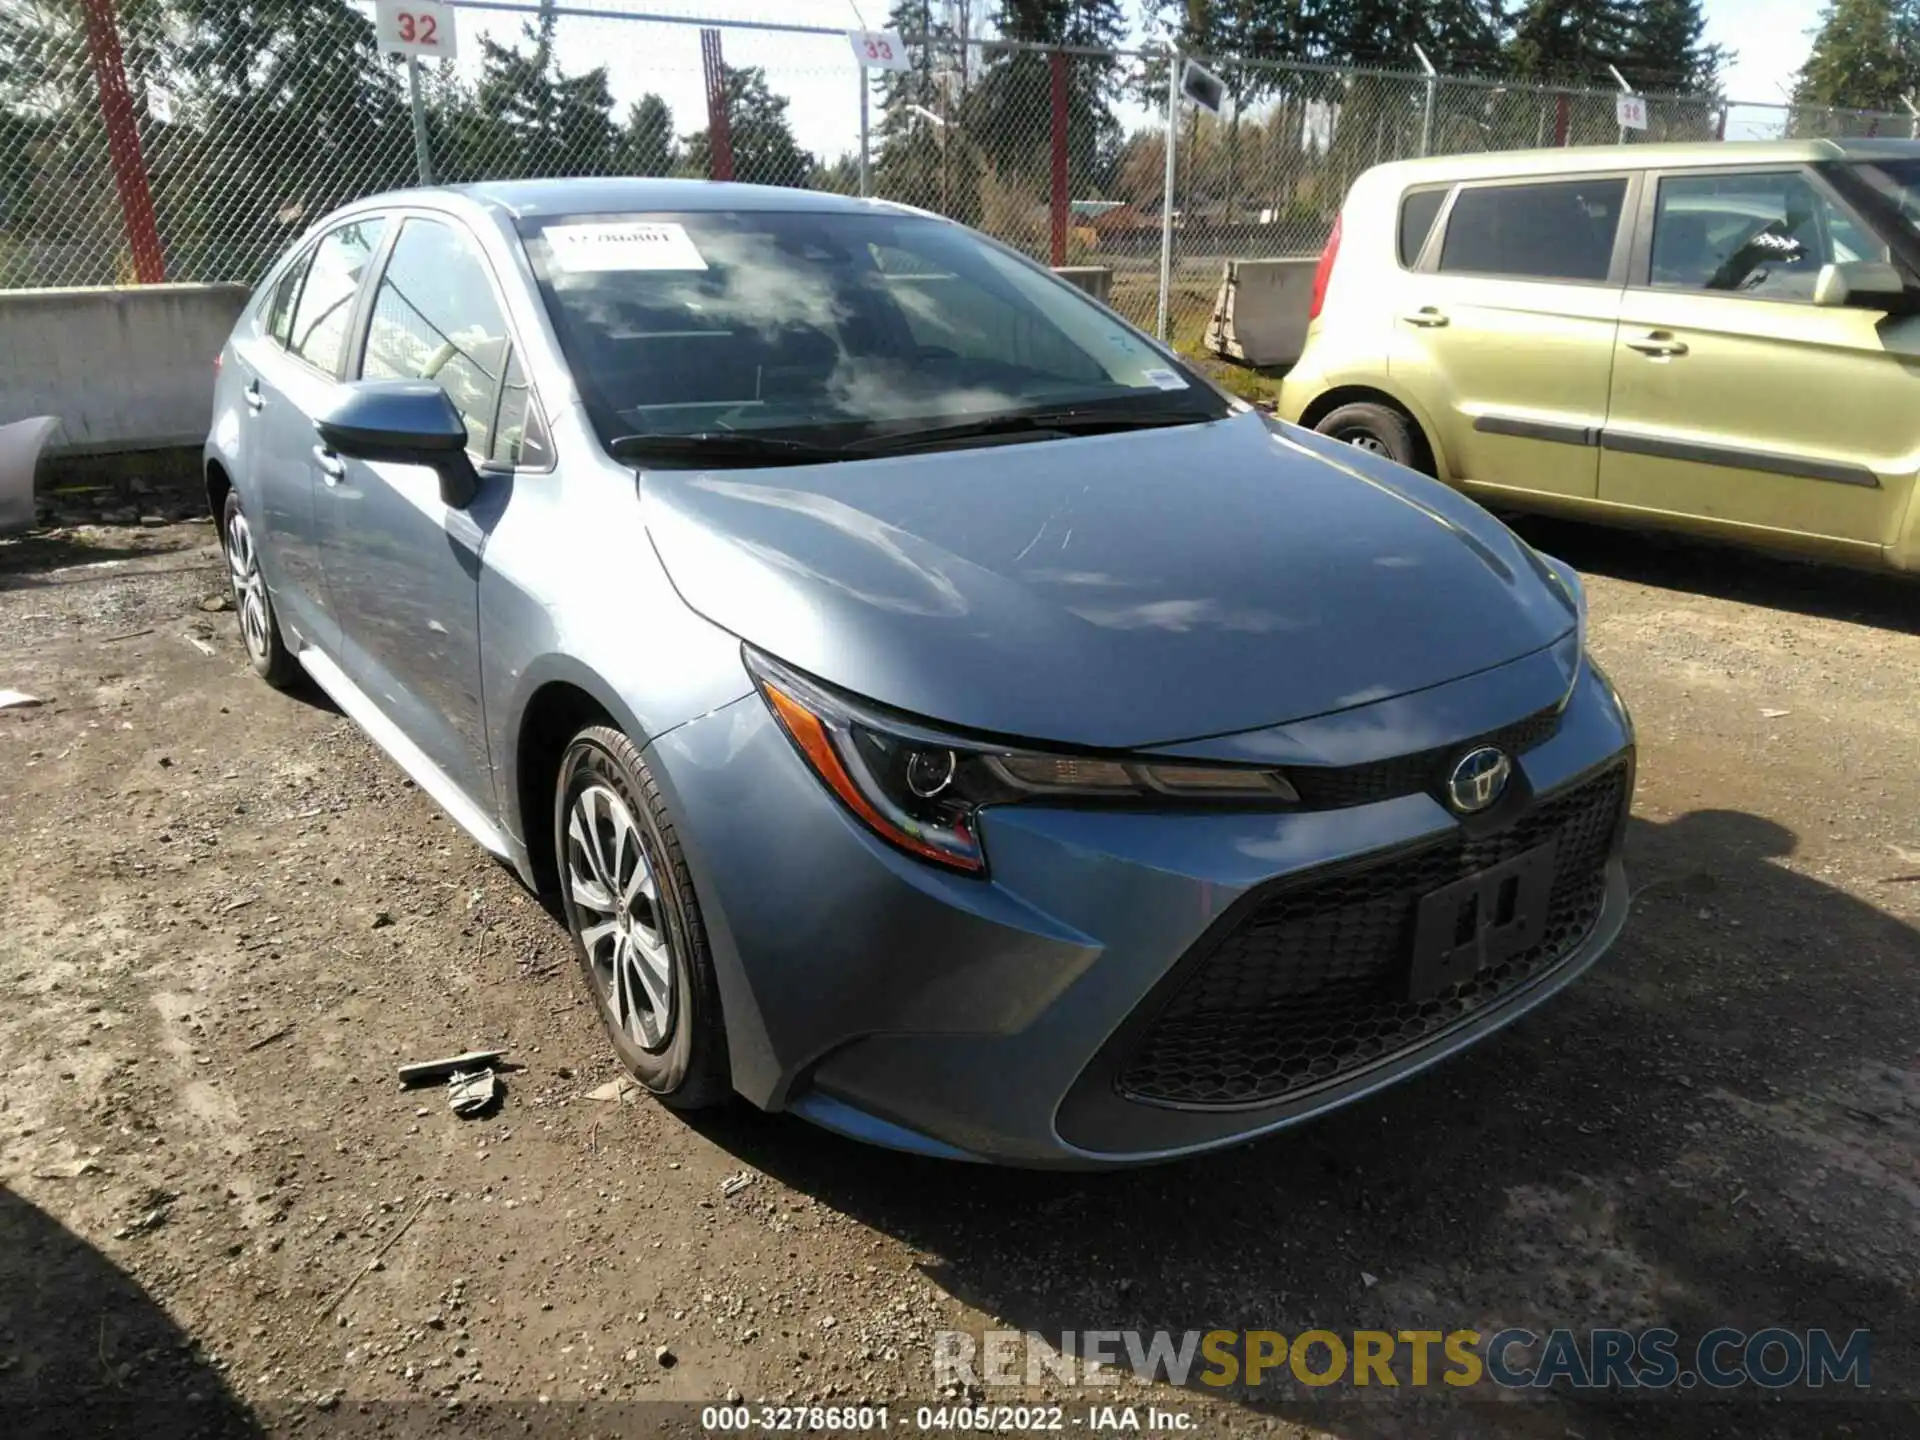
649, 648, 1632, 1167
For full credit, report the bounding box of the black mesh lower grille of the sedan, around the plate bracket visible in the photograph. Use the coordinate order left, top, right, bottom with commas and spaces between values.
1119, 764, 1628, 1106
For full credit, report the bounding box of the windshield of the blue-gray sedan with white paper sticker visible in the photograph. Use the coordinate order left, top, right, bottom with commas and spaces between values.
522, 211, 1227, 444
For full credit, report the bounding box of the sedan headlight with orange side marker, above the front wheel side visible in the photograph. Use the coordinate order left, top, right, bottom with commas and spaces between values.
741, 649, 1300, 874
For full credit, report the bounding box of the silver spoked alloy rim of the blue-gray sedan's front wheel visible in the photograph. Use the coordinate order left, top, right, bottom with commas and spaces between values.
566, 783, 674, 1050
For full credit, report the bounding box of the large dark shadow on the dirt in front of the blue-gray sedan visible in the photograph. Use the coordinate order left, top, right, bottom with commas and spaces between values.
701, 812, 1920, 1440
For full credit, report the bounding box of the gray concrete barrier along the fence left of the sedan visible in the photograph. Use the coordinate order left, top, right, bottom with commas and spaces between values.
0, 284, 250, 457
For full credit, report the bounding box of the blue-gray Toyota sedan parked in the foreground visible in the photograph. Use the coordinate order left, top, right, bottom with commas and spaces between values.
205, 180, 1634, 1165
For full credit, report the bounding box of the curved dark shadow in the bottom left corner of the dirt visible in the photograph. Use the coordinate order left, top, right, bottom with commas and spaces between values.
0, 1187, 263, 1440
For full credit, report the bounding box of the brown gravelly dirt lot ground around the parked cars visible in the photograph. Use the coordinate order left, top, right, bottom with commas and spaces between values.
0, 503, 1920, 1440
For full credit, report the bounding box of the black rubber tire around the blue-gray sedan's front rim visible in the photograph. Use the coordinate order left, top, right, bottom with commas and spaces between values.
553, 726, 733, 1110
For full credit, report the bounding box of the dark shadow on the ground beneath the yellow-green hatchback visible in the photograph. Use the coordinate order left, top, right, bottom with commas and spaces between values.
1503, 515, 1920, 636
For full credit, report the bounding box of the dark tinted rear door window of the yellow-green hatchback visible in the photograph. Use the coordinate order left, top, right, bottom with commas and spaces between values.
1440, 177, 1626, 282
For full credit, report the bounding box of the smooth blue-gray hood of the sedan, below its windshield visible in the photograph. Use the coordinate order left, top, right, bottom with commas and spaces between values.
641, 413, 1572, 749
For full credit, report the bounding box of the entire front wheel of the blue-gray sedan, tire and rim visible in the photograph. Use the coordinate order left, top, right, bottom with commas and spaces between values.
553, 726, 732, 1110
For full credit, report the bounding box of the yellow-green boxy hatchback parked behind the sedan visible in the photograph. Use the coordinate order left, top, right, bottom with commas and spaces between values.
1281, 140, 1920, 570
